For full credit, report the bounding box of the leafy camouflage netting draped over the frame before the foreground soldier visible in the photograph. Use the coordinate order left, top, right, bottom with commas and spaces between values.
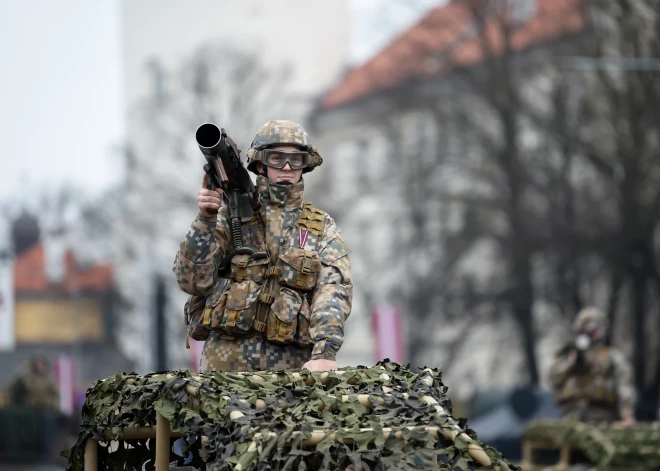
69, 362, 519, 471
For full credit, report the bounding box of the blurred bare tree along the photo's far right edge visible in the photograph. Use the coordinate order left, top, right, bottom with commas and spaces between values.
570, 0, 660, 418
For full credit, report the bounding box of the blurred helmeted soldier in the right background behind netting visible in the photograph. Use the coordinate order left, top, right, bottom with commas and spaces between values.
550, 307, 636, 425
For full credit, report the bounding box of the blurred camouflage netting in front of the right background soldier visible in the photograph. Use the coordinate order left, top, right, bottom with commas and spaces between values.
523, 419, 660, 469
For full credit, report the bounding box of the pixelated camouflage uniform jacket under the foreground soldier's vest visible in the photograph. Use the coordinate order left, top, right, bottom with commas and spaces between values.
173, 176, 353, 369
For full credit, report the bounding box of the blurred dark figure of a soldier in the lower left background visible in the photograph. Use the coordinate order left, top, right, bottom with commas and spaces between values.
9, 357, 60, 410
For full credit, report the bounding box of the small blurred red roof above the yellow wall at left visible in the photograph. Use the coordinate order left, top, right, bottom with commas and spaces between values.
14, 244, 112, 293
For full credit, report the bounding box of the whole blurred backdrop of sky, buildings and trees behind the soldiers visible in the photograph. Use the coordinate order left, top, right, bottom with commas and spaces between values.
0, 0, 660, 470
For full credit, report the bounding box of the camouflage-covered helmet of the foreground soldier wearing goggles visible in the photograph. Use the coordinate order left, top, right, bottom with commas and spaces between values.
247, 119, 323, 174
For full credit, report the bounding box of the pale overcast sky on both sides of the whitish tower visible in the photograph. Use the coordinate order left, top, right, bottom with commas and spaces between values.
0, 0, 439, 205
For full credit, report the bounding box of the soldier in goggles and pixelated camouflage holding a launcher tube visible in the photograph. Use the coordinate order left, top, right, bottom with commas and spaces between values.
173, 120, 353, 371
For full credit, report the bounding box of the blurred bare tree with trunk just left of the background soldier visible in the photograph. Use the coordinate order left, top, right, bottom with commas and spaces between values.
402, 1, 588, 384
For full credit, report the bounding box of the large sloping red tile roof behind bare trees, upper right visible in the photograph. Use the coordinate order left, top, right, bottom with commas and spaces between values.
320, 0, 585, 110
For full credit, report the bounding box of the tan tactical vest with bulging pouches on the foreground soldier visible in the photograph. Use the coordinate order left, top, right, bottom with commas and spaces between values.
184, 202, 325, 348
